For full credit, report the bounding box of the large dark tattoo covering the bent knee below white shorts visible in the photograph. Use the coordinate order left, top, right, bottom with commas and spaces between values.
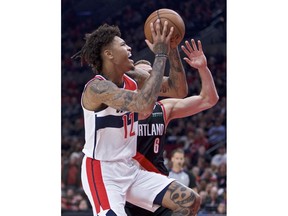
168, 182, 199, 216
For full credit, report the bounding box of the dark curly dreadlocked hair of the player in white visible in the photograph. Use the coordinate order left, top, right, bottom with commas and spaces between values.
74, 23, 121, 72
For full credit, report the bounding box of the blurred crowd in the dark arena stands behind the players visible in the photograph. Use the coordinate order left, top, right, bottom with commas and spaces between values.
61, 0, 226, 216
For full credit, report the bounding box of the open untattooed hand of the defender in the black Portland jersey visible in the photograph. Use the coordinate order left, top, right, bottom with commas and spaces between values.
181, 39, 207, 69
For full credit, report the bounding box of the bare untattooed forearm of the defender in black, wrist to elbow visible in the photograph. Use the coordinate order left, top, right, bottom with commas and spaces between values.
198, 66, 219, 106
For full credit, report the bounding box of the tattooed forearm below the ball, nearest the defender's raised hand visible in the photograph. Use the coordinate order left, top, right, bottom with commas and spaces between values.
168, 47, 188, 98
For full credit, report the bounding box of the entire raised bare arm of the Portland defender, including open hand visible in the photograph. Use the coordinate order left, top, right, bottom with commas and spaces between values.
161, 39, 219, 121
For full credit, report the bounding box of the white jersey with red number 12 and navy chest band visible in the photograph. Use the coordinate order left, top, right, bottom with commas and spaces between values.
82, 74, 138, 161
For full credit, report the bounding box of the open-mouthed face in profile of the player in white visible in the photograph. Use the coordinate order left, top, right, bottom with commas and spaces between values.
111, 36, 134, 71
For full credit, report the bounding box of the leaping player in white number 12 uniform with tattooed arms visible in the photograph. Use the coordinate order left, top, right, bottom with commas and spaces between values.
80, 19, 200, 216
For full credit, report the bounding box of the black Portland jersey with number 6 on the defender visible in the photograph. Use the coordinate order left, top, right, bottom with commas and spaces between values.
134, 102, 169, 176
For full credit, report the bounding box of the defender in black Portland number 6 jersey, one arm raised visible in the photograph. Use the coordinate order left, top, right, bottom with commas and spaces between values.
125, 39, 218, 216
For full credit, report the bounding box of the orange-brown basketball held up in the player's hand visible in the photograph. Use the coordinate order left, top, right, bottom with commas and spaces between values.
144, 8, 185, 48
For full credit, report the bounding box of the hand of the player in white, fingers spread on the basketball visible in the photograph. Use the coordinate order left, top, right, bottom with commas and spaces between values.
145, 19, 174, 55
